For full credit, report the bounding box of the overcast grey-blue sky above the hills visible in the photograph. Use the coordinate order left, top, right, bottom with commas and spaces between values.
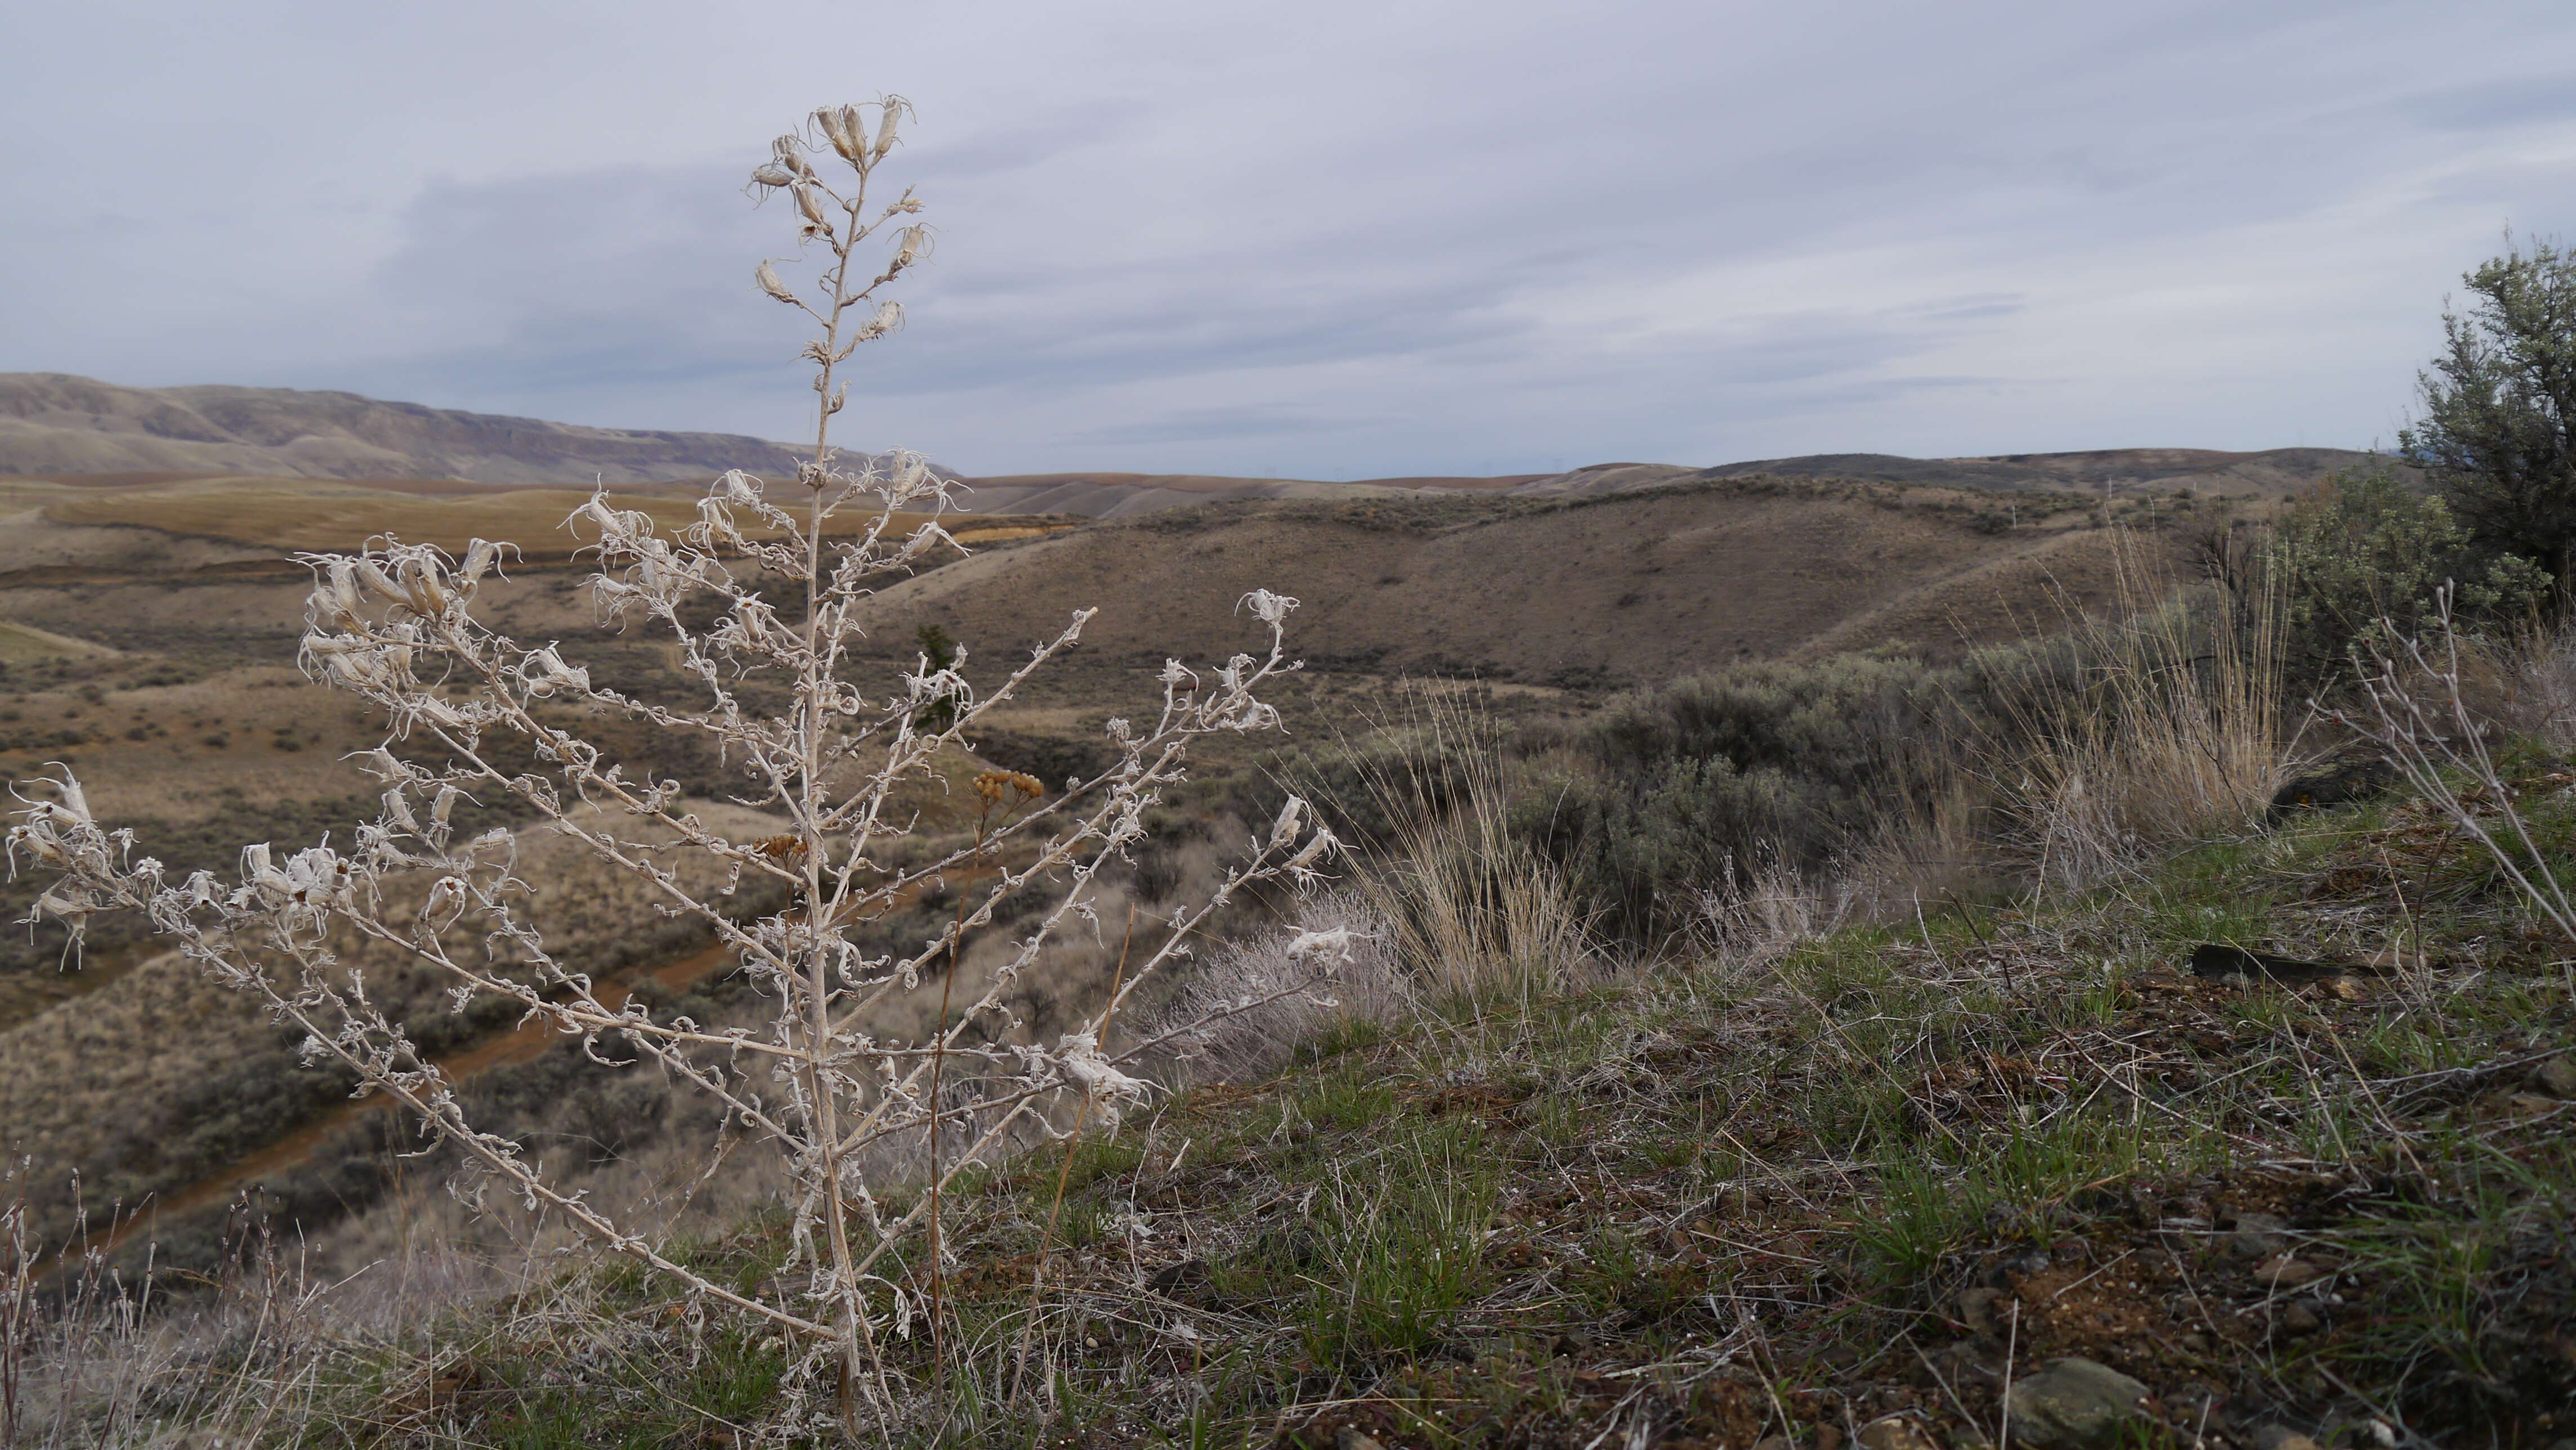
0, 0, 2576, 479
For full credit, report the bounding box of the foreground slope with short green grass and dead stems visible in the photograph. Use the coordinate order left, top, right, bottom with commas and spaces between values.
261, 778, 2576, 1447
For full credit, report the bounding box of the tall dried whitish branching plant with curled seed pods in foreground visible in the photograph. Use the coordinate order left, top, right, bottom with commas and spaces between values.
8, 98, 1337, 1417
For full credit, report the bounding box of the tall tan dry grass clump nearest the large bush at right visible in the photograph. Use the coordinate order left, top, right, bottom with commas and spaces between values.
1989, 541, 2293, 886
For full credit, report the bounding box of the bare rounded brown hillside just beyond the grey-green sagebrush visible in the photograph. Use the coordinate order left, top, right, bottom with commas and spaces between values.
839, 479, 2172, 683
